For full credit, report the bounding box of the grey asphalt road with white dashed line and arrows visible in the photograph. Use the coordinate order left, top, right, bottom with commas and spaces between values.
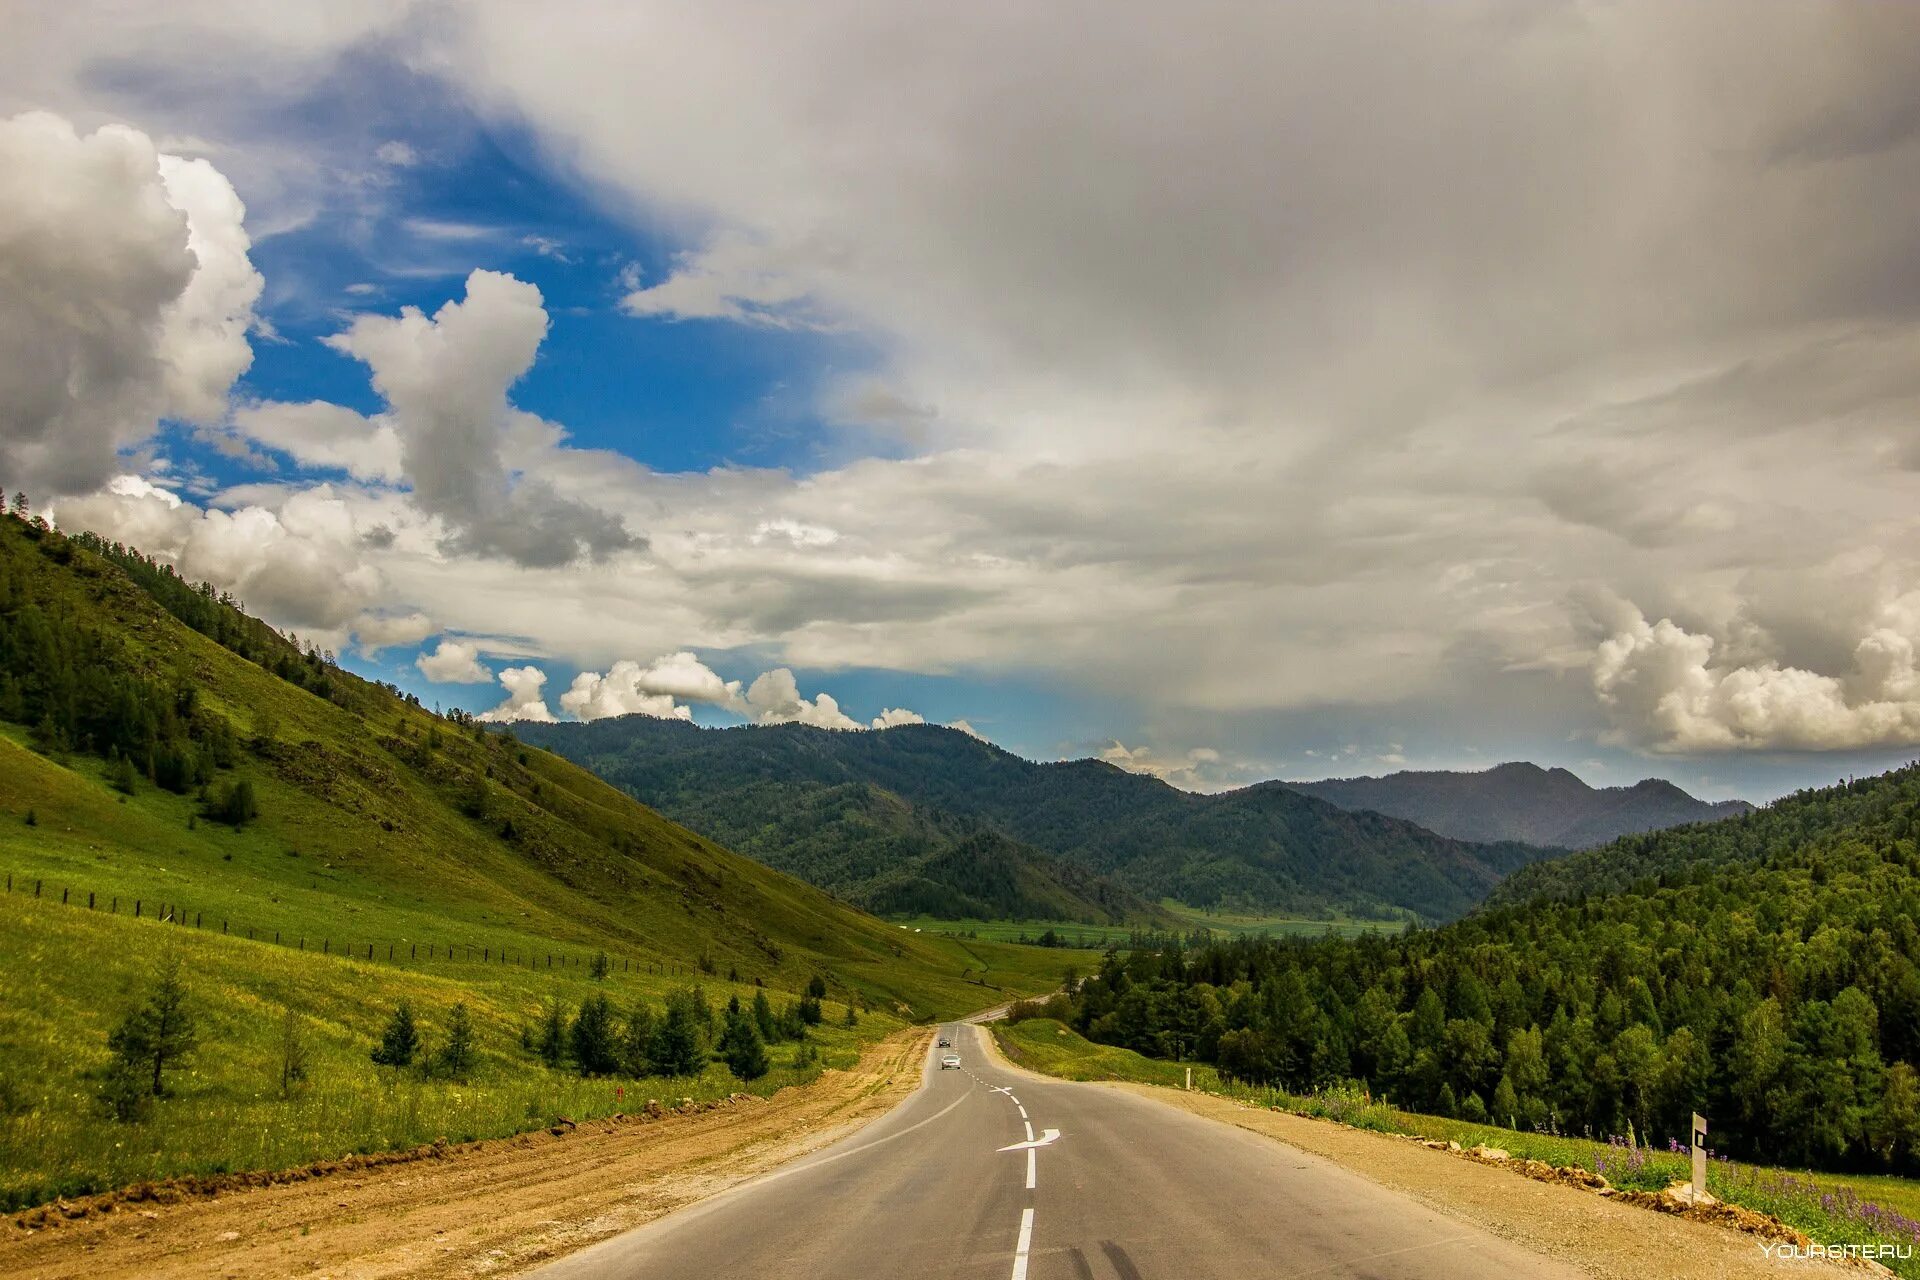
536, 1023, 1580, 1280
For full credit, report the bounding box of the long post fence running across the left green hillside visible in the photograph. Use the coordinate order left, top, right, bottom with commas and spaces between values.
6, 871, 706, 977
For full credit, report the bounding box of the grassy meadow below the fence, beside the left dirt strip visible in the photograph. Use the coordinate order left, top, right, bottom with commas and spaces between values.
0, 894, 879, 1209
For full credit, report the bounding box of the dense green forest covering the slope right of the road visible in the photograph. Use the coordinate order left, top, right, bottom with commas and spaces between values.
1071, 768, 1920, 1171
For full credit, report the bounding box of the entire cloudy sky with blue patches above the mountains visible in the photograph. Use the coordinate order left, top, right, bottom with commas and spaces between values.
0, 0, 1920, 798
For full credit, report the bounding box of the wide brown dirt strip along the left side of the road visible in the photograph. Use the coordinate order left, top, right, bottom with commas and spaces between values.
0, 1029, 931, 1280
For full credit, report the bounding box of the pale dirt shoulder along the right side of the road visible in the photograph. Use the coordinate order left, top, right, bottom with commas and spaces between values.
987, 1034, 1850, 1280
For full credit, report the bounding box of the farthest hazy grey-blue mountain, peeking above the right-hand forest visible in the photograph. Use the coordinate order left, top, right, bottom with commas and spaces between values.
1284, 762, 1753, 848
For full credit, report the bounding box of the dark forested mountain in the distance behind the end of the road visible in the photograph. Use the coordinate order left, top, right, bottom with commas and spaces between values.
522, 716, 1548, 919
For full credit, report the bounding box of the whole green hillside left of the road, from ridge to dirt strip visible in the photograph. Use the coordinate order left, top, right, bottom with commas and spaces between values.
0, 518, 1085, 1203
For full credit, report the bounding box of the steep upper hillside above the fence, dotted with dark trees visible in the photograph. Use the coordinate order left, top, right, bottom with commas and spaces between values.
0, 516, 1052, 1009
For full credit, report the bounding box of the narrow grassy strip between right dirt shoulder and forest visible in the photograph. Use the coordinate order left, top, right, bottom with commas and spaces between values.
993, 1017, 1920, 1276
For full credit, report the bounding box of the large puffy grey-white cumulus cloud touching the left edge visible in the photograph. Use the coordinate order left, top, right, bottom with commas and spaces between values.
0, 111, 261, 495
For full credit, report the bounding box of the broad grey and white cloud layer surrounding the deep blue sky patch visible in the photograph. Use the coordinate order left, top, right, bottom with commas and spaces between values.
11, 0, 1920, 775
